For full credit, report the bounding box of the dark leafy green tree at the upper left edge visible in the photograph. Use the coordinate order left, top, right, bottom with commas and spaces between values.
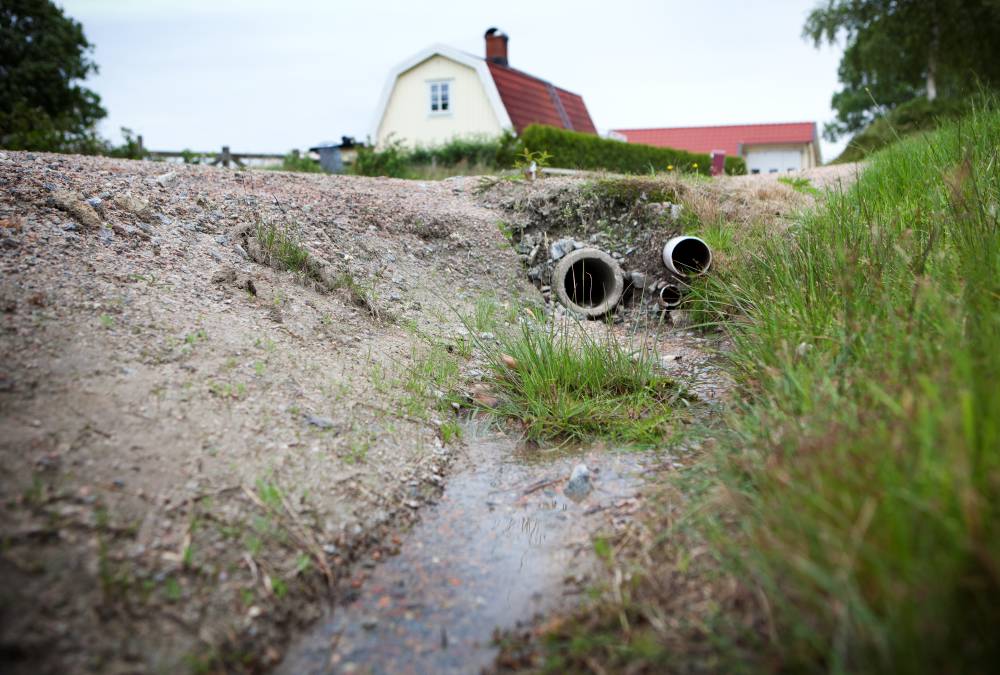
0, 0, 107, 152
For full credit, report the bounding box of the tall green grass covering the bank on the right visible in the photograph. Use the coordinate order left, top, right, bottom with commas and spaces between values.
709, 100, 1000, 673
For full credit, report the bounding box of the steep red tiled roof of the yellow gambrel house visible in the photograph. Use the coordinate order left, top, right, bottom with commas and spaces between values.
486, 61, 597, 134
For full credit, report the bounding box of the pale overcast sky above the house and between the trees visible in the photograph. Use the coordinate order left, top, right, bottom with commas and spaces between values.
57, 0, 843, 161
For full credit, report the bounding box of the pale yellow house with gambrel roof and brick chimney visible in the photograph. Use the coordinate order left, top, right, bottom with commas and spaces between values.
372, 28, 597, 147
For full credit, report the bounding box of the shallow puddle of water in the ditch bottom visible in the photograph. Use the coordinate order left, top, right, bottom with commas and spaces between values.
275, 428, 653, 675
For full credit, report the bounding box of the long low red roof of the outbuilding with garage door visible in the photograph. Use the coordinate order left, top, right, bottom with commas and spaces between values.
615, 122, 816, 157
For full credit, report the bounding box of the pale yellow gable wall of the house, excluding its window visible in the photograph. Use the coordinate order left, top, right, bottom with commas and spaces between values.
376, 55, 502, 147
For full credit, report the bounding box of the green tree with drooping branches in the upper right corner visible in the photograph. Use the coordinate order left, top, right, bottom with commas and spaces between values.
803, 0, 1000, 140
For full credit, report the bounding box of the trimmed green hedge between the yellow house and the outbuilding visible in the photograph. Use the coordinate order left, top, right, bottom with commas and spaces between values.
520, 124, 746, 176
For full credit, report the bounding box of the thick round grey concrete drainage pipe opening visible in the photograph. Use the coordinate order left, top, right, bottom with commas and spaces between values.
552, 248, 625, 319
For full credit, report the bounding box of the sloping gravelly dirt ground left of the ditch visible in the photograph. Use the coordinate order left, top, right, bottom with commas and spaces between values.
0, 152, 847, 673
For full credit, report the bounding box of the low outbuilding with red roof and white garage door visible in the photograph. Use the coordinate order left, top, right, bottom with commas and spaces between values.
611, 122, 821, 173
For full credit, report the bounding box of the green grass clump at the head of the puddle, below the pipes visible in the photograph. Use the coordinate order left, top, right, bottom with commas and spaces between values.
482, 321, 682, 445
